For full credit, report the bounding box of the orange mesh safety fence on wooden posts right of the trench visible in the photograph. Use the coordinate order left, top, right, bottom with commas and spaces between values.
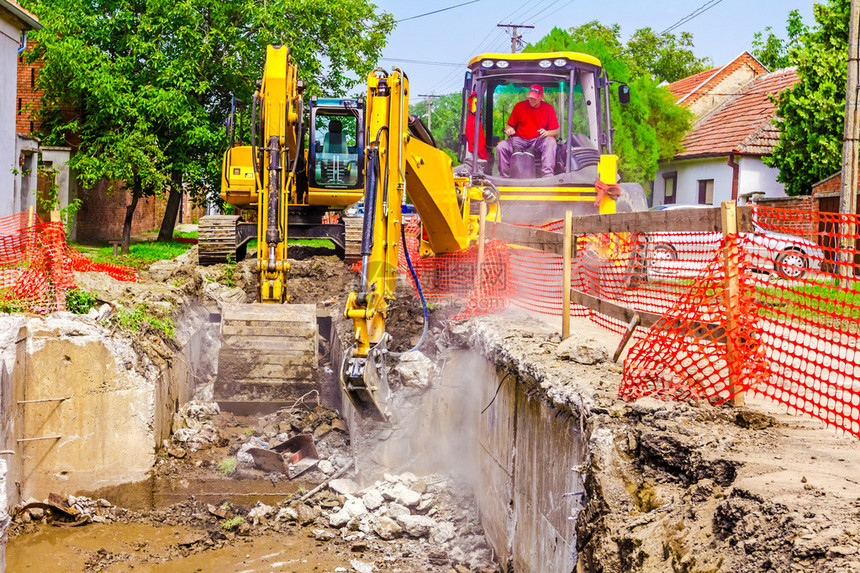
362, 206, 860, 437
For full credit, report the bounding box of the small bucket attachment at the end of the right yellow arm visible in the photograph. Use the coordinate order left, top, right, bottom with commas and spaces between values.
340, 333, 391, 422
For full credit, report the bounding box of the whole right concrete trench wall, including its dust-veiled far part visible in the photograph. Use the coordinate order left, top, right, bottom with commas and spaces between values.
344, 350, 586, 573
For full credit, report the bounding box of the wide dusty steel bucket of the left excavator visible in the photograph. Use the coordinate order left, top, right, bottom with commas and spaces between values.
214, 303, 319, 413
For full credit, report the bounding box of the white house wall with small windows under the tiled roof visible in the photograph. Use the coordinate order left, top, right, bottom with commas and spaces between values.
653, 156, 785, 207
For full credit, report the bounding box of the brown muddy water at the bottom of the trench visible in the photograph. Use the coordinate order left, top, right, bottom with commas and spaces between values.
6, 523, 350, 573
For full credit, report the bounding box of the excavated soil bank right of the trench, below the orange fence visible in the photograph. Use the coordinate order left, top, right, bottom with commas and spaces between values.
453, 311, 860, 573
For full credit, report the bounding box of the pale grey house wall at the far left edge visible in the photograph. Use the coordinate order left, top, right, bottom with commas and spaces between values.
0, 10, 21, 217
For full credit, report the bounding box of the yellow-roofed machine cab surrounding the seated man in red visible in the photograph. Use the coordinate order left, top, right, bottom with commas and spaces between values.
458, 52, 626, 224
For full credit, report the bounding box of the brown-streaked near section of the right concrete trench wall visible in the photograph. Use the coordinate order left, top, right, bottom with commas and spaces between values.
475, 356, 586, 572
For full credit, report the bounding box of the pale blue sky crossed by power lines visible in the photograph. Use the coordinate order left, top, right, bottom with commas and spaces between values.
376, 0, 813, 95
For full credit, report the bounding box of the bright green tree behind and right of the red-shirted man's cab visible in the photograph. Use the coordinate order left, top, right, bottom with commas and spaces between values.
526, 28, 692, 183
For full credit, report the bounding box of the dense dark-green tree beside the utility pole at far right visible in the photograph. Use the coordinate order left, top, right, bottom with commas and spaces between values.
763, 0, 850, 195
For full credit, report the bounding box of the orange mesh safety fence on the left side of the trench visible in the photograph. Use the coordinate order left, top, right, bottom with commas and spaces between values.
0, 213, 137, 314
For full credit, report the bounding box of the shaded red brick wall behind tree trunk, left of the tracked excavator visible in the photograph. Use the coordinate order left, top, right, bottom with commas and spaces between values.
77, 180, 165, 242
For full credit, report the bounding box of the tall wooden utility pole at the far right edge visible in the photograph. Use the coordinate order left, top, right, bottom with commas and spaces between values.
839, 0, 860, 280
